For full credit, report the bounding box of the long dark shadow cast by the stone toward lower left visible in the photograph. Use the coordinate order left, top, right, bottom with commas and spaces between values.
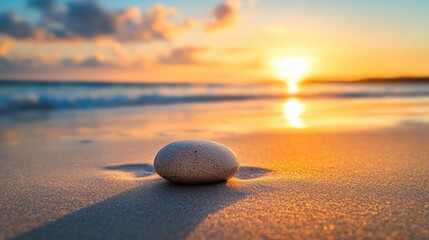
15, 179, 247, 240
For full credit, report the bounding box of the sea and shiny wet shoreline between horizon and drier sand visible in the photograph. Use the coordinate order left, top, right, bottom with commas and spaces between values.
0, 81, 429, 148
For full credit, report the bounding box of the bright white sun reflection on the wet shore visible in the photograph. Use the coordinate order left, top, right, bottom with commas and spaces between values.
283, 98, 307, 128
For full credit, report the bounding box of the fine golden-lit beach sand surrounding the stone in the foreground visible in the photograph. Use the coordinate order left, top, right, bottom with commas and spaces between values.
0, 124, 429, 239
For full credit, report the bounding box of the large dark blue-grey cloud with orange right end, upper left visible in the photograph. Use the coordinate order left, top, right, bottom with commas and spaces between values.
0, 0, 195, 42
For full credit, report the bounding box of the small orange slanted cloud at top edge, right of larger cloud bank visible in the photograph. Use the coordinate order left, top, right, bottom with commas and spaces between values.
206, 1, 241, 32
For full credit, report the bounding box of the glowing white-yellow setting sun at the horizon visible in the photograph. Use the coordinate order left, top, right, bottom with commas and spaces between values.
272, 57, 310, 94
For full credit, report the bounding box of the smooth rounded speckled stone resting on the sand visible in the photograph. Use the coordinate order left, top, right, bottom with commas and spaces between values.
154, 140, 239, 184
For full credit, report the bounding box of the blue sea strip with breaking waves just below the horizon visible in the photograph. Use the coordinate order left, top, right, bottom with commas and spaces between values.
0, 81, 429, 111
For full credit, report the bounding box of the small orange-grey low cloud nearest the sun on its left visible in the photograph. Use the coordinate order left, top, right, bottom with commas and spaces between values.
158, 47, 207, 65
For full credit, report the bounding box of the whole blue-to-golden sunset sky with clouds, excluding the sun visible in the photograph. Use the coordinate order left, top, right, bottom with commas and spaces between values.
0, 0, 429, 82
